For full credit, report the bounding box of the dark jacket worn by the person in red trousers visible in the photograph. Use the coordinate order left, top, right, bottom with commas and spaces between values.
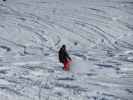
59, 47, 71, 63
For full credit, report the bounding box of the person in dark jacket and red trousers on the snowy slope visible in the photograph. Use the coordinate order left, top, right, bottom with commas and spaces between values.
58, 45, 72, 71
